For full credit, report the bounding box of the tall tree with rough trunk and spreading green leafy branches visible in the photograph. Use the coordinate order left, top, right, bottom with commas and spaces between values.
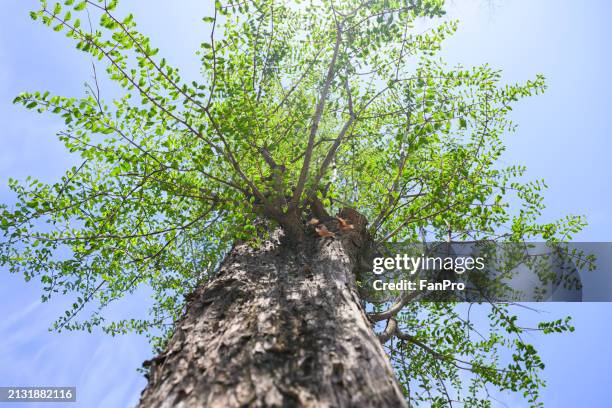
0, 0, 584, 406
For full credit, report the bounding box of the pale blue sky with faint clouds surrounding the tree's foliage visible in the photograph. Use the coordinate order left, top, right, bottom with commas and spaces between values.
0, 0, 612, 407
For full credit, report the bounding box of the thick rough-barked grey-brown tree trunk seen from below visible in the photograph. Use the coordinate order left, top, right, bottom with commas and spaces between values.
140, 220, 405, 408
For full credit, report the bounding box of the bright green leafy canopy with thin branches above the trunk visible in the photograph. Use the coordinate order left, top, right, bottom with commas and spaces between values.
0, 0, 584, 406
